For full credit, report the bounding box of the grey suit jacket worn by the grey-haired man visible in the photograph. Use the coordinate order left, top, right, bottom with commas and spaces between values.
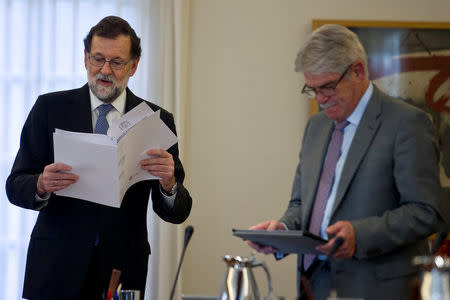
281, 87, 441, 300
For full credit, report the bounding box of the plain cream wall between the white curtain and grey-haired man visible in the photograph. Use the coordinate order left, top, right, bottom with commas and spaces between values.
181, 0, 450, 299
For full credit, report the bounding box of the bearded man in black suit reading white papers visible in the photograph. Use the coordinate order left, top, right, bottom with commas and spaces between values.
6, 17, 192, 300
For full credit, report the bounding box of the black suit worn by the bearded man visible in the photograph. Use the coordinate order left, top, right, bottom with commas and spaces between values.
6, 85, 192, 299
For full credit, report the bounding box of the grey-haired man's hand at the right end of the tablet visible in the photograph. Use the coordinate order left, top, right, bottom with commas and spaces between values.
316, 221, 356, 258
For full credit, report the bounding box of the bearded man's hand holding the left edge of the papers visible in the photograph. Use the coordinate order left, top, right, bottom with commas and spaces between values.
36, 163, 78, 196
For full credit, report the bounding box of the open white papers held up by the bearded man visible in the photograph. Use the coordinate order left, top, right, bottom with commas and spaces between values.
53, 103, 178, 207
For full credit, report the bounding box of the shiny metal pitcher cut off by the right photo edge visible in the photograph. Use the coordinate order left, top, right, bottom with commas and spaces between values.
413, 256, 450, 300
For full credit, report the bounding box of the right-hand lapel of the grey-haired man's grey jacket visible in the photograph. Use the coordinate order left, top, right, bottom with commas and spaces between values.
332, 86, 381, 216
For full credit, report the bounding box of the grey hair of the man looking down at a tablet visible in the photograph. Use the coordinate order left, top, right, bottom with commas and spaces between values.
295, 24, 368, 78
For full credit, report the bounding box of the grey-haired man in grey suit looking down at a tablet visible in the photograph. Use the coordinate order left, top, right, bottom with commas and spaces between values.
250, 25, 442, 300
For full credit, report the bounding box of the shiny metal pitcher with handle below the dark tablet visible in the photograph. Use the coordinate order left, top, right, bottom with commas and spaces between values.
218, 254, 273, 300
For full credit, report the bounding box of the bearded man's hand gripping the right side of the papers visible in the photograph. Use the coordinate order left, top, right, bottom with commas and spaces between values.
141, 149, 175, 192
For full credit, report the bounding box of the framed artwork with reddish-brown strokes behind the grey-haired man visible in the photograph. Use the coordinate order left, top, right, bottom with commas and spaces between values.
310, 20, 450, 246
